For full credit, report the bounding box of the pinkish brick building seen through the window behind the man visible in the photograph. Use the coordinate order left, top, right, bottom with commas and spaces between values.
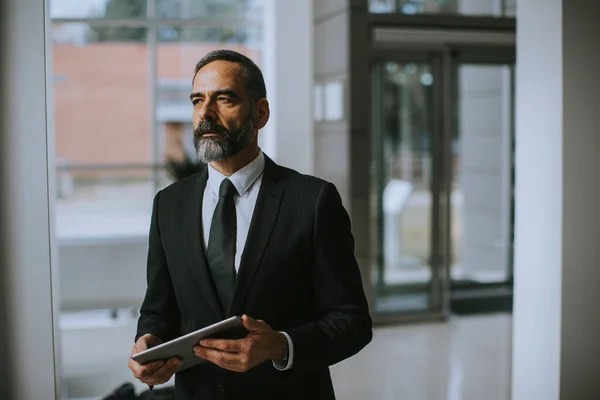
53, 42, 260, 179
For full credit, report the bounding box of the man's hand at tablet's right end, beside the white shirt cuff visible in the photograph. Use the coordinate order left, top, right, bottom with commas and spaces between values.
194, 315, 288, 372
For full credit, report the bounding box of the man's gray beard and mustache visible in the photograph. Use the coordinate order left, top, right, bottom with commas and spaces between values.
194, 118, 254, 163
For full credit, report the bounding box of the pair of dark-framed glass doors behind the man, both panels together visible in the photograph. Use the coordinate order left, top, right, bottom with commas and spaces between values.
372, 41, 514, 321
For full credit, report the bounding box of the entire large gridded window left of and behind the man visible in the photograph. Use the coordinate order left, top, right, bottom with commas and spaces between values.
50, 0, 263, 399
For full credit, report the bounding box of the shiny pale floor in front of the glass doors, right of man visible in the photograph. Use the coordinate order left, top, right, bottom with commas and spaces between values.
332, 314, 512, 400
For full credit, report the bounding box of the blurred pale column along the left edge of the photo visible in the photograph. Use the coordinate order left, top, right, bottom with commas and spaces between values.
0, 0, 57, 400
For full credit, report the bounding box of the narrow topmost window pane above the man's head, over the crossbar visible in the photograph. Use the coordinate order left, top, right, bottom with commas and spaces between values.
156, 0, 264, 22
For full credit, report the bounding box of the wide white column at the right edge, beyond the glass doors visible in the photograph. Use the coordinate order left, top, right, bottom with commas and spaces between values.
512, 0, 600, 400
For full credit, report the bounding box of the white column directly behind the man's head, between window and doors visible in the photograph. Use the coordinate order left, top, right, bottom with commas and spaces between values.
260, 0, 314, 174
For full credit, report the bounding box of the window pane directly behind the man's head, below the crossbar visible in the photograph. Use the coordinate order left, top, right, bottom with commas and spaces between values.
155, 28, 262, 161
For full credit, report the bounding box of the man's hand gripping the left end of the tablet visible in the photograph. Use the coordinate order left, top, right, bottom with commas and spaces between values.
129, 334, 182, 386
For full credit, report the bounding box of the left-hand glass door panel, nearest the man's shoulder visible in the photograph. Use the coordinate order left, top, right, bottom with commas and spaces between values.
373, 53, 450, 317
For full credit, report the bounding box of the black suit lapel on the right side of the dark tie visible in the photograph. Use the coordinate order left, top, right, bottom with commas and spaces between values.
227, 155, 283, 316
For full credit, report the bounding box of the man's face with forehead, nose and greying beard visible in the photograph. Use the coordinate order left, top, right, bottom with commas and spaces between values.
190, 61, 256, 162
